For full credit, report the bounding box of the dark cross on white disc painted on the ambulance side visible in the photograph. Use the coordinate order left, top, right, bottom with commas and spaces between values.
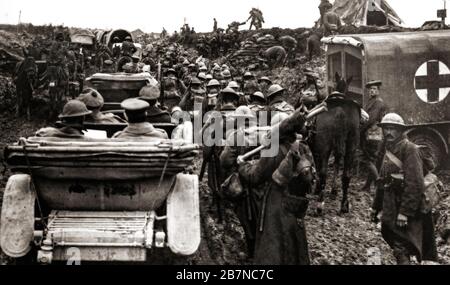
414, 60, 450, 103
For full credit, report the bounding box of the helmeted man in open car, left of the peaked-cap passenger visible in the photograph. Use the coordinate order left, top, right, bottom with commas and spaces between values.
36, 100, 92, 139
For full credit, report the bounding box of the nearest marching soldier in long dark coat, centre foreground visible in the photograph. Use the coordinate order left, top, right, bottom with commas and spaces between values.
238, 110, 310, 265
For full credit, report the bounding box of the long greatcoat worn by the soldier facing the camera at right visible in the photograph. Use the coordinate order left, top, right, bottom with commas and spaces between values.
373, 136, 437, 261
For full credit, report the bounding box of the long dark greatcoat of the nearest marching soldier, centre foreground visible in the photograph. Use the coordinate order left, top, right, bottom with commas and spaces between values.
239, 138, 309, 265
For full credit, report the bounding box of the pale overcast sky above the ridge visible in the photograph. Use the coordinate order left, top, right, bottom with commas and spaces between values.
0, 0, 450, 33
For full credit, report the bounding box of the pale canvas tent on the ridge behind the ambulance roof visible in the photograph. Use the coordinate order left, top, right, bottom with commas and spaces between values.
331, 0, 403, 26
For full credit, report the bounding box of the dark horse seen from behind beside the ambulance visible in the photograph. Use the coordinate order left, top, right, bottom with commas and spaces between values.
311, 73, 361, 215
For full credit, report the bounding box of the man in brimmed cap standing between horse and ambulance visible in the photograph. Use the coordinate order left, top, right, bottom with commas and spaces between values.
361, 80, 387, 191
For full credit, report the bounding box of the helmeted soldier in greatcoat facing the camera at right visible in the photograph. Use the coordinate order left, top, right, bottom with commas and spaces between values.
371, 113, 437, 265
